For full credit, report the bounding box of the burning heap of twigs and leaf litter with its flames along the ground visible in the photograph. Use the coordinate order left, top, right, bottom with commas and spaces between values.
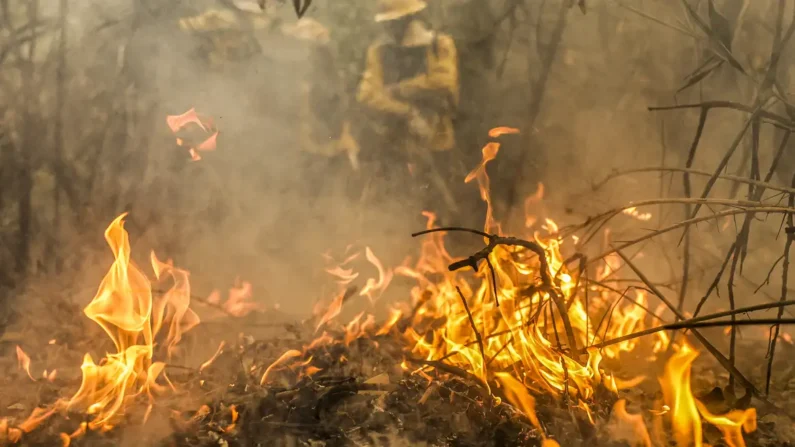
0, 133, 793, 447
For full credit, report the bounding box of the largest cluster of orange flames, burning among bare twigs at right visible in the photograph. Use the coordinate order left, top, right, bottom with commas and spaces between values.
304, 129, 755, 447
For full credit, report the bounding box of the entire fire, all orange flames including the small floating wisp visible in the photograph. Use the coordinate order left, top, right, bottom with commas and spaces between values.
0, 126, 756, 447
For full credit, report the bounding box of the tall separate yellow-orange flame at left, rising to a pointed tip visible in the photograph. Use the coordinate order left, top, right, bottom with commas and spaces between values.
64, 214, 199, 429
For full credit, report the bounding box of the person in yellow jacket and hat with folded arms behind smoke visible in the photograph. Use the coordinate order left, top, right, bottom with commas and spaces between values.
357, 0, 462, 219
